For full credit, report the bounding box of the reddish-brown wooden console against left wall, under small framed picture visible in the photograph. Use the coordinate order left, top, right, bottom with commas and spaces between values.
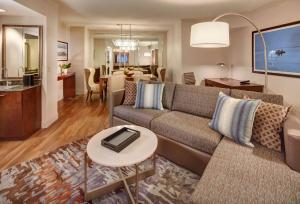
57, 72, 76, 98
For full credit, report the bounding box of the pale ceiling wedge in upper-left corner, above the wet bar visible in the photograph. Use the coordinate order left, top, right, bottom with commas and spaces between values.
0, 0, 40, 16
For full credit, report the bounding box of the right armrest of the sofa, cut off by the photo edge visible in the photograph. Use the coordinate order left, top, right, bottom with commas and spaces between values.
284, 117, 300, 172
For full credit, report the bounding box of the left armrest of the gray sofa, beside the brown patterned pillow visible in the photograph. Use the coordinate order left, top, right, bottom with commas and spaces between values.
109, 89, 125, 127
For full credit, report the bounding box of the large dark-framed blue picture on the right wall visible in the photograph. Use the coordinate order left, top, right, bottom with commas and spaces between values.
252, 21, 300, 78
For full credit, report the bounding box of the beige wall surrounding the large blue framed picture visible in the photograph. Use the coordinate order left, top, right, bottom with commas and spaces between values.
228, 0, 300, 118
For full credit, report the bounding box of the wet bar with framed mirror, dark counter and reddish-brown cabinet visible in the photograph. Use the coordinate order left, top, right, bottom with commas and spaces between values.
0, 25, 43, 139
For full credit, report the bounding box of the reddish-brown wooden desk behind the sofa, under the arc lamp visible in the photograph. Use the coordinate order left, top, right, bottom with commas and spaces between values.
205, 78, 264, 92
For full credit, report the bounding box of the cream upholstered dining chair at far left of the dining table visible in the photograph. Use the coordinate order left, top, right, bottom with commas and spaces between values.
84, 68, 100, 101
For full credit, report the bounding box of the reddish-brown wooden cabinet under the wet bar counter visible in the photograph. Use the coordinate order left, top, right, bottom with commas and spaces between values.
0, 86, 42, 139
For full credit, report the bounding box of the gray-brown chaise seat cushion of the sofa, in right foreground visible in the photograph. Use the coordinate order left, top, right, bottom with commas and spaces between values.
192, 138, 300, 204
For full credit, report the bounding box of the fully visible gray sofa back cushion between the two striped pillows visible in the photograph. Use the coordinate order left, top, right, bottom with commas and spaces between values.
172, 84, 230, 118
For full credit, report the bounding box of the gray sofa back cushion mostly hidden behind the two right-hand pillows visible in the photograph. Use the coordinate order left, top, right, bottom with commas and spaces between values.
231, 89, 283, 105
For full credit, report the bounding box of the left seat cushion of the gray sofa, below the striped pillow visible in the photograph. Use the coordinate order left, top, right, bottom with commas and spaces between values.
114, 105, 168, 129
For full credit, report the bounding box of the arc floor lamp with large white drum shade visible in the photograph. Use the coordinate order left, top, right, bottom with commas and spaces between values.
190, 13, 268, 92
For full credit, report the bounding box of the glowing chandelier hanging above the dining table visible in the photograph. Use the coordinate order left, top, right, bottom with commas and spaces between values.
113, 24, 138, 51
